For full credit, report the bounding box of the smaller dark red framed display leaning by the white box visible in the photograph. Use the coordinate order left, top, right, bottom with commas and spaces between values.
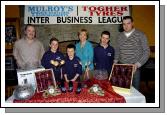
35, 69, 56, 93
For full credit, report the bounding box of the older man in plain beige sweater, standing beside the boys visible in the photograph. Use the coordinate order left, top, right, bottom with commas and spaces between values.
13, 24, 44, 69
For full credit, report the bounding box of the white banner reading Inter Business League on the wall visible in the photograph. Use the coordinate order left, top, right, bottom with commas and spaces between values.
24, 5, 130, 24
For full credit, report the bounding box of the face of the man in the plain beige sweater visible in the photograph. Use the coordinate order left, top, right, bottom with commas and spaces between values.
25, 25, 35, 40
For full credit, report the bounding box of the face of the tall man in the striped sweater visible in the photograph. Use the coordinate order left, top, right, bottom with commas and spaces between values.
123, 19, 133, 32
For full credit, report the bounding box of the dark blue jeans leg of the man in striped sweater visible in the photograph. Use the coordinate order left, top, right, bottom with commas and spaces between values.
132, 68, 140, 90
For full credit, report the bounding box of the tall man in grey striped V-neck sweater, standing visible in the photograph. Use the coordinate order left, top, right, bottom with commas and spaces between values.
114, 16, 150, 90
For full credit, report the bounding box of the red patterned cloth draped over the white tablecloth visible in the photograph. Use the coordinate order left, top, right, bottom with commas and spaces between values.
14, 79, 126, 103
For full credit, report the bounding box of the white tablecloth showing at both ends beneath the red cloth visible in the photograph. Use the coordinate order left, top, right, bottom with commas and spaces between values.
6, 87, 146, 103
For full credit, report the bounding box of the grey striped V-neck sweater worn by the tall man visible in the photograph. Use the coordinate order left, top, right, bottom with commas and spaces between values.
115, 29, 150, 66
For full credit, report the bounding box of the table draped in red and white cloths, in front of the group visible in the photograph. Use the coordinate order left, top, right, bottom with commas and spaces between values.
6, 81, 146, 103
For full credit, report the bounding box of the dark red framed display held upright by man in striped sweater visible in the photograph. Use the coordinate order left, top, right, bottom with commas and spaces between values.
109, 64, 134, 93
